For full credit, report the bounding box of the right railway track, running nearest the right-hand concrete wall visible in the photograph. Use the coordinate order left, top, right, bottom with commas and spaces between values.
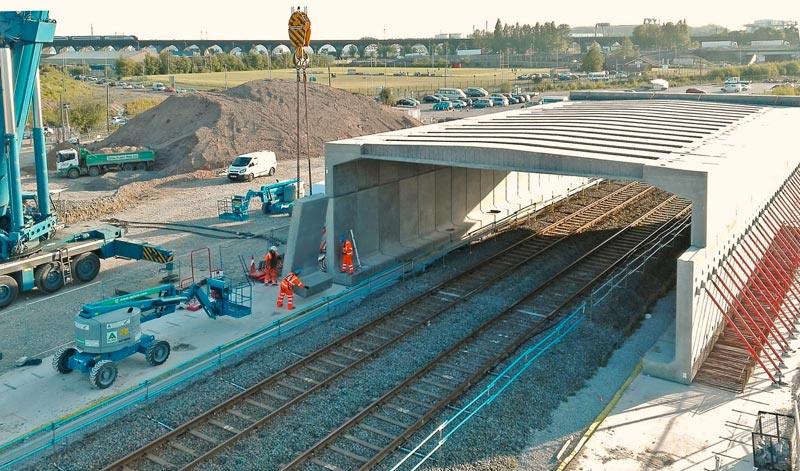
284, 196, 690, 471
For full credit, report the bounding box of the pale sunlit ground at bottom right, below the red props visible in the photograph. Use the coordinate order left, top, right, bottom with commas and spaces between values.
566, 290, 800, 471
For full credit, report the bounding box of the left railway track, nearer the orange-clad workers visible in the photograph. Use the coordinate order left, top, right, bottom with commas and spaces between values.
101, 182, 654, 470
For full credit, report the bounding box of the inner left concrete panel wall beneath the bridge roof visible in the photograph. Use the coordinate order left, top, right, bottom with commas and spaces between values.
326, 158, 589, 284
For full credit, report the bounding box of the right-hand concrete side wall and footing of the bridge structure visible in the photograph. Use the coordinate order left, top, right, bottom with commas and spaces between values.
644, 110, 800, 384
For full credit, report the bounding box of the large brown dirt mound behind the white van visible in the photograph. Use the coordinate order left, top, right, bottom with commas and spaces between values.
99, 80, 420, 173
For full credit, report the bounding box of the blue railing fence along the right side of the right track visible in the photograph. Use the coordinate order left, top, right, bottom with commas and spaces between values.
390, 203, 691, 471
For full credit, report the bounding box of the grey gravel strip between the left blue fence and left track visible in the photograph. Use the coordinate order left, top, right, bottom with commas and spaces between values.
20, 229, 530, 470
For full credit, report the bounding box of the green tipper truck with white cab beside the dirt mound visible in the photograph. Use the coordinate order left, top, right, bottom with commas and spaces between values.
56, 147, 156, 178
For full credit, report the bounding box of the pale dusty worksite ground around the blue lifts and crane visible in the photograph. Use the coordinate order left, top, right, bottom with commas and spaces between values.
0, 159, 332, 442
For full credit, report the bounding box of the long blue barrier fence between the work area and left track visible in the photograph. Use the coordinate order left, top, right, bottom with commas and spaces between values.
0, 180, 599, 470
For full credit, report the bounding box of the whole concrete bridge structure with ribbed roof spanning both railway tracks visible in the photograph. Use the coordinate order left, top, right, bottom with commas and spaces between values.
287, 94, 800, 383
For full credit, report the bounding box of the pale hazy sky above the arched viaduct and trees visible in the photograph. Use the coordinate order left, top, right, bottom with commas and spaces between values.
7, 0, 800, 39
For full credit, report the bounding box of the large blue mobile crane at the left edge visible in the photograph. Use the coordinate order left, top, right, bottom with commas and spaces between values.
0, 10, 173, 309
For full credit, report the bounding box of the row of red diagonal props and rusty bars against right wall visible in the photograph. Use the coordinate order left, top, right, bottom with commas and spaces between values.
697, 167, 800, 390
